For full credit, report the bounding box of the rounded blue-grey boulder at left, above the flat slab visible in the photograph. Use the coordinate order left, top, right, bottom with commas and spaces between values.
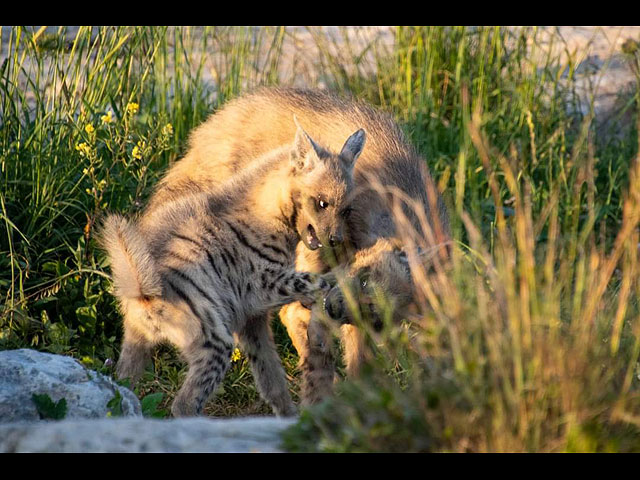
0, 349, 142, 423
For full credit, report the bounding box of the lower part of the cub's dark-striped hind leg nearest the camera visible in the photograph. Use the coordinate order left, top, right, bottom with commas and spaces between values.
171, 326, 233, 417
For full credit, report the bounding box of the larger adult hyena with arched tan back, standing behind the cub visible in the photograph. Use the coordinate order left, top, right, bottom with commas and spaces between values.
149, 88, 449, 403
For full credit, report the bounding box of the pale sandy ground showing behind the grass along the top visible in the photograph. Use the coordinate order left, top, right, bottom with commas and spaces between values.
0, 26, 640, 122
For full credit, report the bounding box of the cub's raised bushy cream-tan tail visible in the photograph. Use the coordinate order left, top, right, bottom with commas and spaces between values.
100, 214, 162, 299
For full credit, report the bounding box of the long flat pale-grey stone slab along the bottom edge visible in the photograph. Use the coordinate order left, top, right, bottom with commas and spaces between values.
0, 417, 295, 453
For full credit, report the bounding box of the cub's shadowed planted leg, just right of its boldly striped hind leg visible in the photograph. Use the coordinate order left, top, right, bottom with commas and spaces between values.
238, 315, 297, 417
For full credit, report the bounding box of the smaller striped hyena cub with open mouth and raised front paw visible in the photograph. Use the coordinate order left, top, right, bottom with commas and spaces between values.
102, 120, 365, 416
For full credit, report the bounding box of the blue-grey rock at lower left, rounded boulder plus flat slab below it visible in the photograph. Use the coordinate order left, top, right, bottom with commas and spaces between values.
0, 349, 295, 453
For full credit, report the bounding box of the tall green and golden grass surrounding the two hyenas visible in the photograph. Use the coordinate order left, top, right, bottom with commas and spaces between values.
0, 27, 640, 451
